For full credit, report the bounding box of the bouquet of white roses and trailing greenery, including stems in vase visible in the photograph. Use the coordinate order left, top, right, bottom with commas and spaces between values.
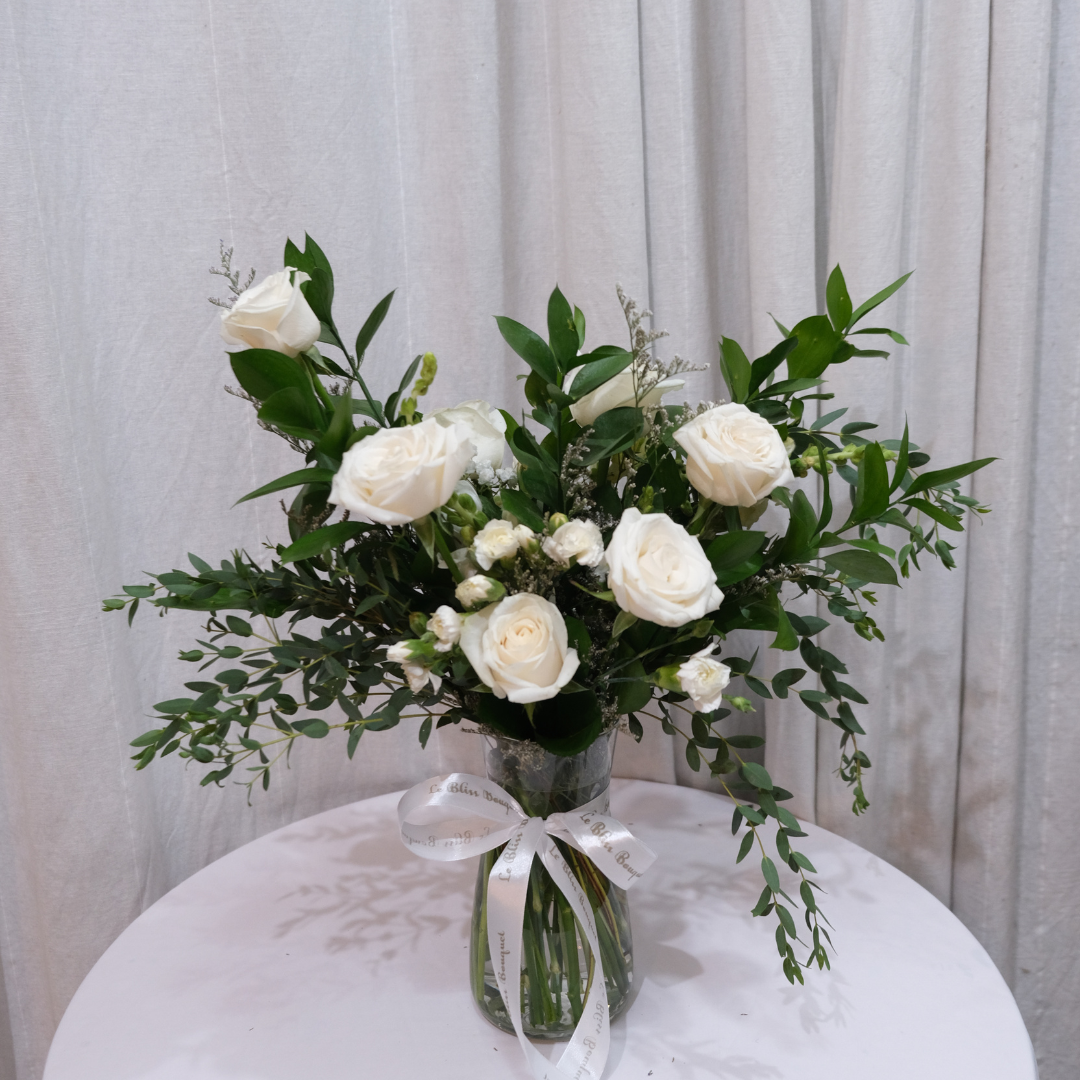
105, 238, 993, 1019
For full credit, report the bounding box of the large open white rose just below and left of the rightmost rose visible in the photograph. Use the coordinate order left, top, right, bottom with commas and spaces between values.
607, 507, 724, 626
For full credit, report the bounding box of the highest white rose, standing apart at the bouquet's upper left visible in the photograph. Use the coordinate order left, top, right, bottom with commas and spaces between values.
221, 267, 322, 356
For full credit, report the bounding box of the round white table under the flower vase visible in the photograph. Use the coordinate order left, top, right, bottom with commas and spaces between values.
44, 781, 1037, 1080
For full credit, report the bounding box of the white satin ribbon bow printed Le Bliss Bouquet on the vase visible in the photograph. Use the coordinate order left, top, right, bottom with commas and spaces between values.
397, 772, 657, 1080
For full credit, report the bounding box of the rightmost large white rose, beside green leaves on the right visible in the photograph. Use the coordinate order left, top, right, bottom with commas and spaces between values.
674, 402, 795, 507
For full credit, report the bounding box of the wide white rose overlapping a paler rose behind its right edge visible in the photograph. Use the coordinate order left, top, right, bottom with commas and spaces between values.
329, 420, 473, 525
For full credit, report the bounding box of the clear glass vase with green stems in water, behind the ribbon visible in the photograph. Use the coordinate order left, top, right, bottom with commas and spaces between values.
470, 730, 633, 1040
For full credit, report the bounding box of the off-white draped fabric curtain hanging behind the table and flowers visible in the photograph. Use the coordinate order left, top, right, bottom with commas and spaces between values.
0, 0, 1080, 1080
